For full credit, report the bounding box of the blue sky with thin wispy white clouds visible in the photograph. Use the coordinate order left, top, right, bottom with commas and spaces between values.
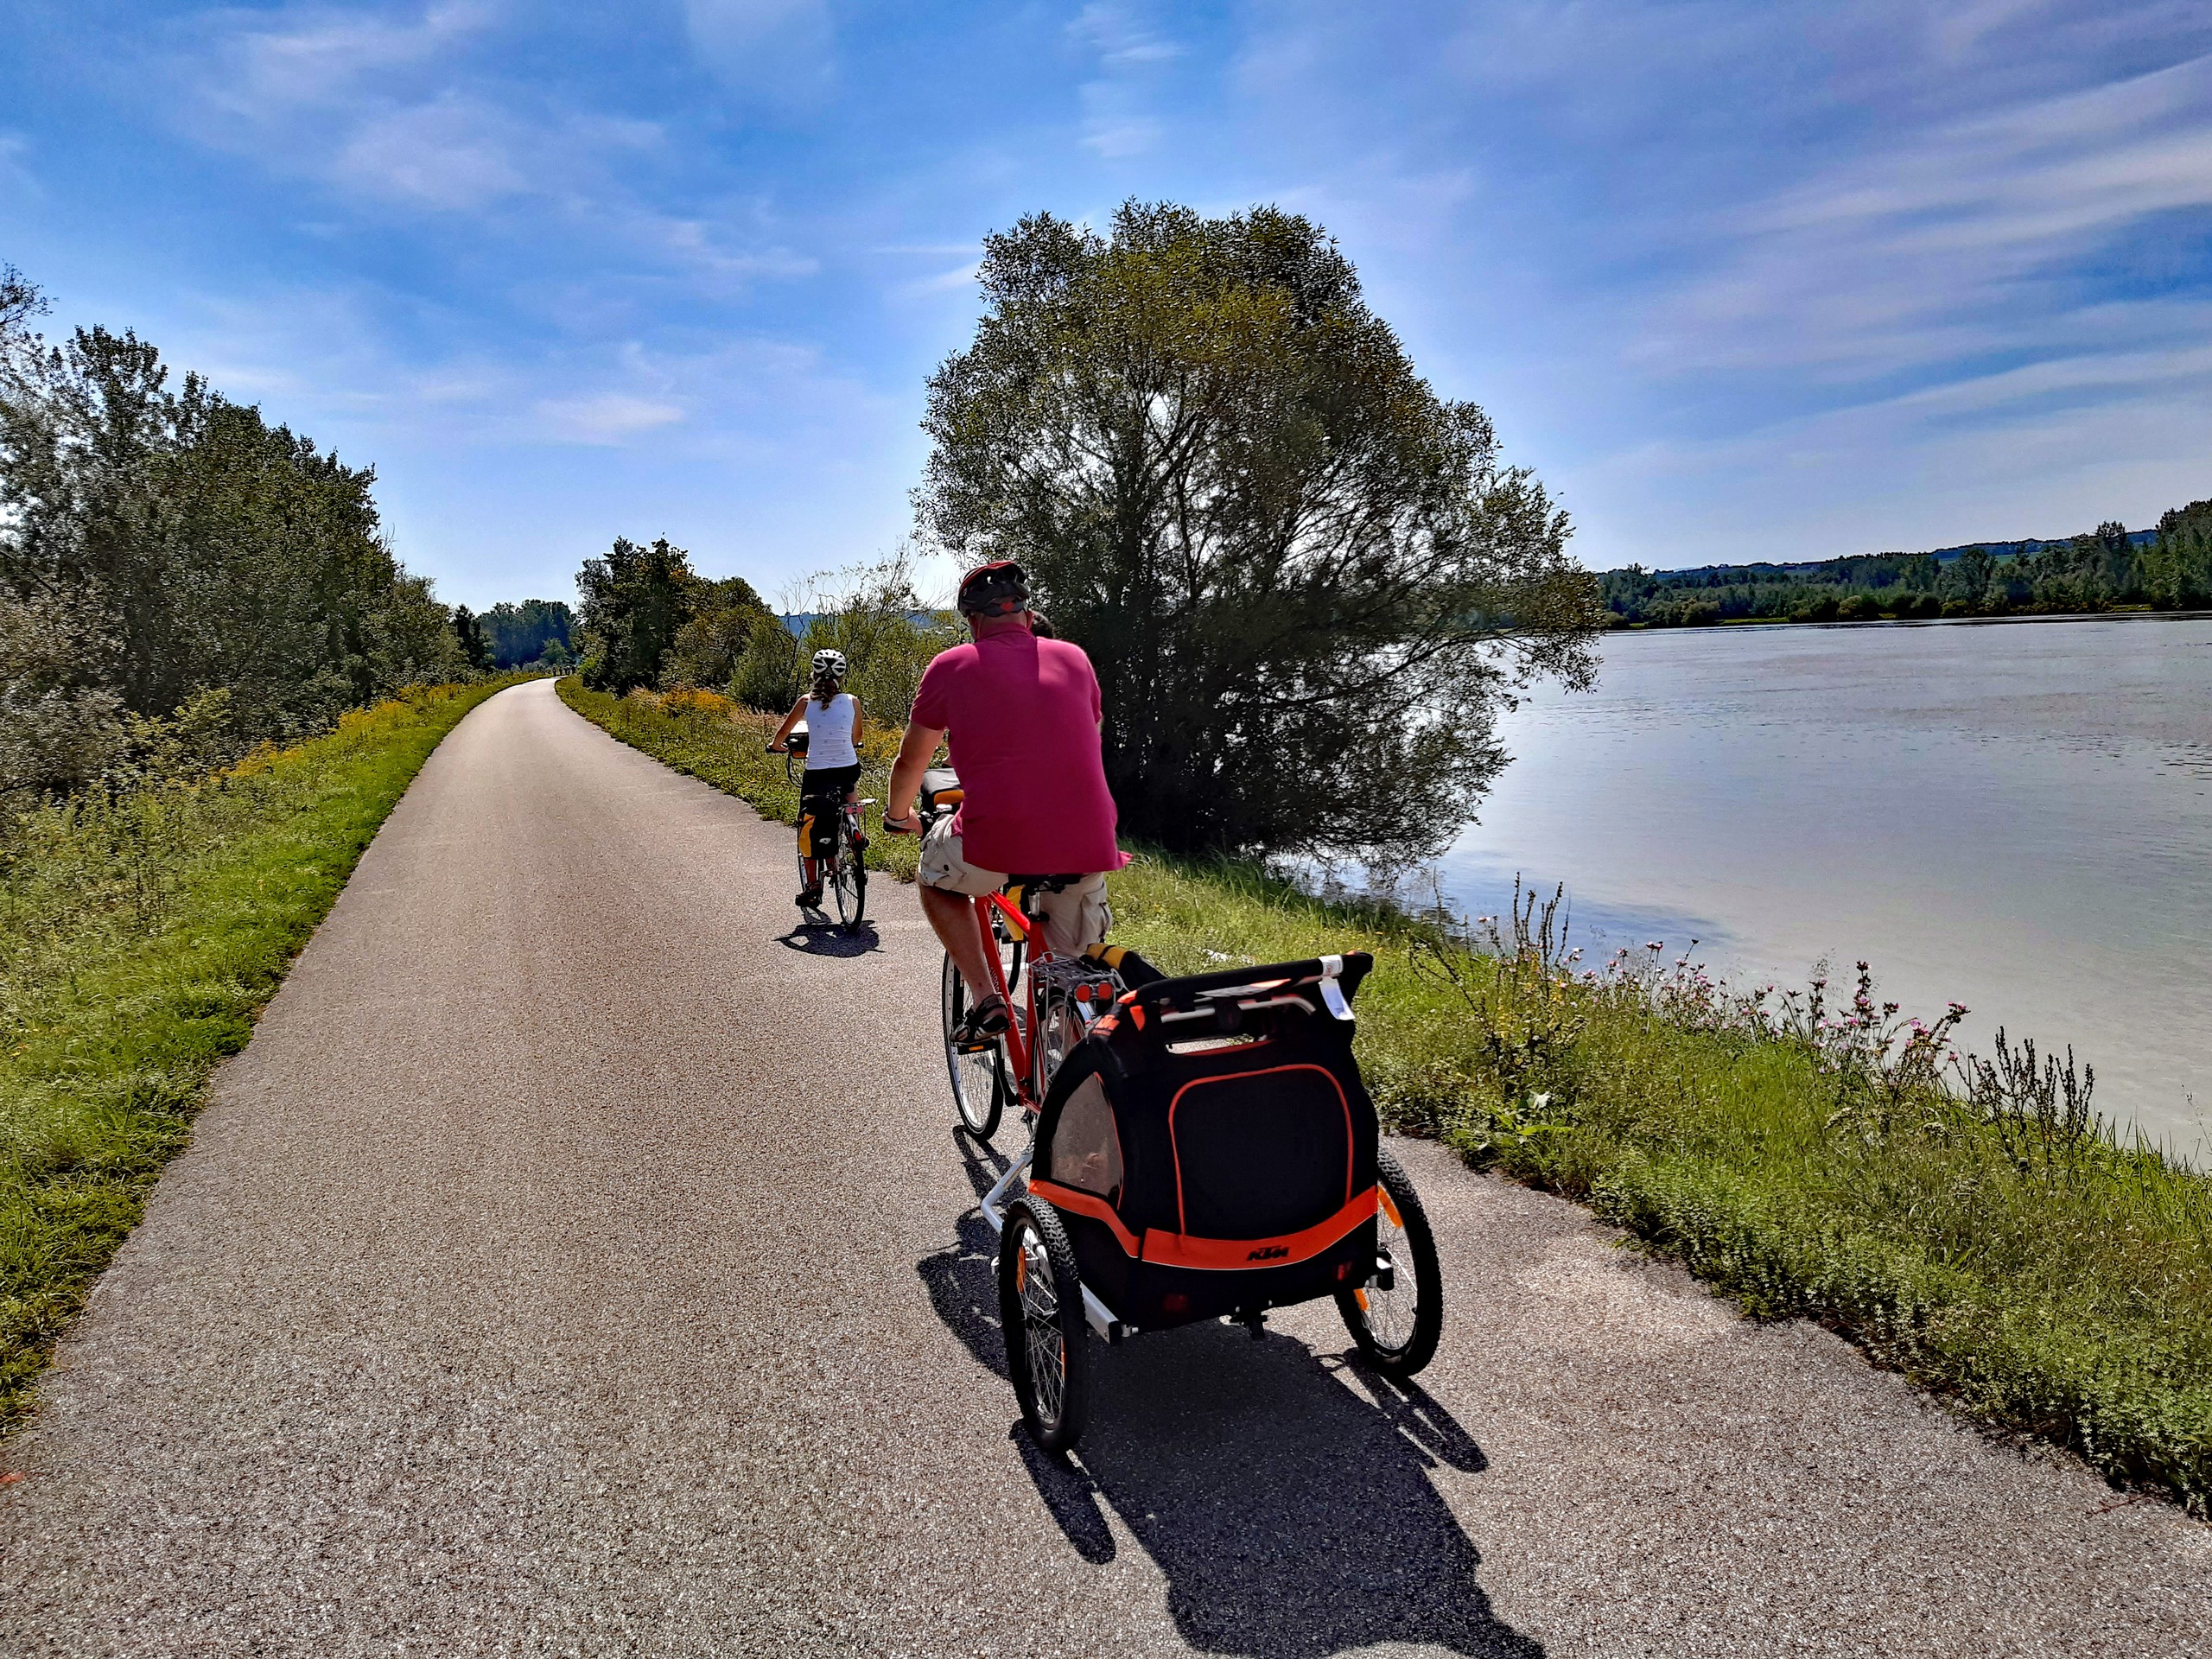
0, 0, 2212, 606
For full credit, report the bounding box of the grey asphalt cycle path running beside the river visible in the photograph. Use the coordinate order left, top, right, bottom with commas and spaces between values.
0, 683, 2212, 1659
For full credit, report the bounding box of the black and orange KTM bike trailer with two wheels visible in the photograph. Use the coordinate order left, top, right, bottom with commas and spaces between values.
982, 953, 1442, 1451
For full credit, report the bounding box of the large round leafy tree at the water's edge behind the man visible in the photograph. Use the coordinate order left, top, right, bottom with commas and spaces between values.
916, 204, 1599, 856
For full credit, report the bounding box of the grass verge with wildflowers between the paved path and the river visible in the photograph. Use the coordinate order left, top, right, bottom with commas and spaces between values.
562, 681, 2212, 1516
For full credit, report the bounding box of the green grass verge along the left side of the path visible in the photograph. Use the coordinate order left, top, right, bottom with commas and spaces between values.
0, 677, 524, 1431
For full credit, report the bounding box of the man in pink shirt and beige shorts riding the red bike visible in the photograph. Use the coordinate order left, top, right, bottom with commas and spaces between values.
882, 560, 1128, 1038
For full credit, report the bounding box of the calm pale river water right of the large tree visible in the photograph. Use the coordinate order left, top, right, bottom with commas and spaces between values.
1440, 617, 2212, 1161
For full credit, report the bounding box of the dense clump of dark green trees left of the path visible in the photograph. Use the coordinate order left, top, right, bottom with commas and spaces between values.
0, 289, 460, 787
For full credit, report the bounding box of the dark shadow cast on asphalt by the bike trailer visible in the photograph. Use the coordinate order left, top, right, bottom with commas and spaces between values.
918, 1148, 1544, 1659
